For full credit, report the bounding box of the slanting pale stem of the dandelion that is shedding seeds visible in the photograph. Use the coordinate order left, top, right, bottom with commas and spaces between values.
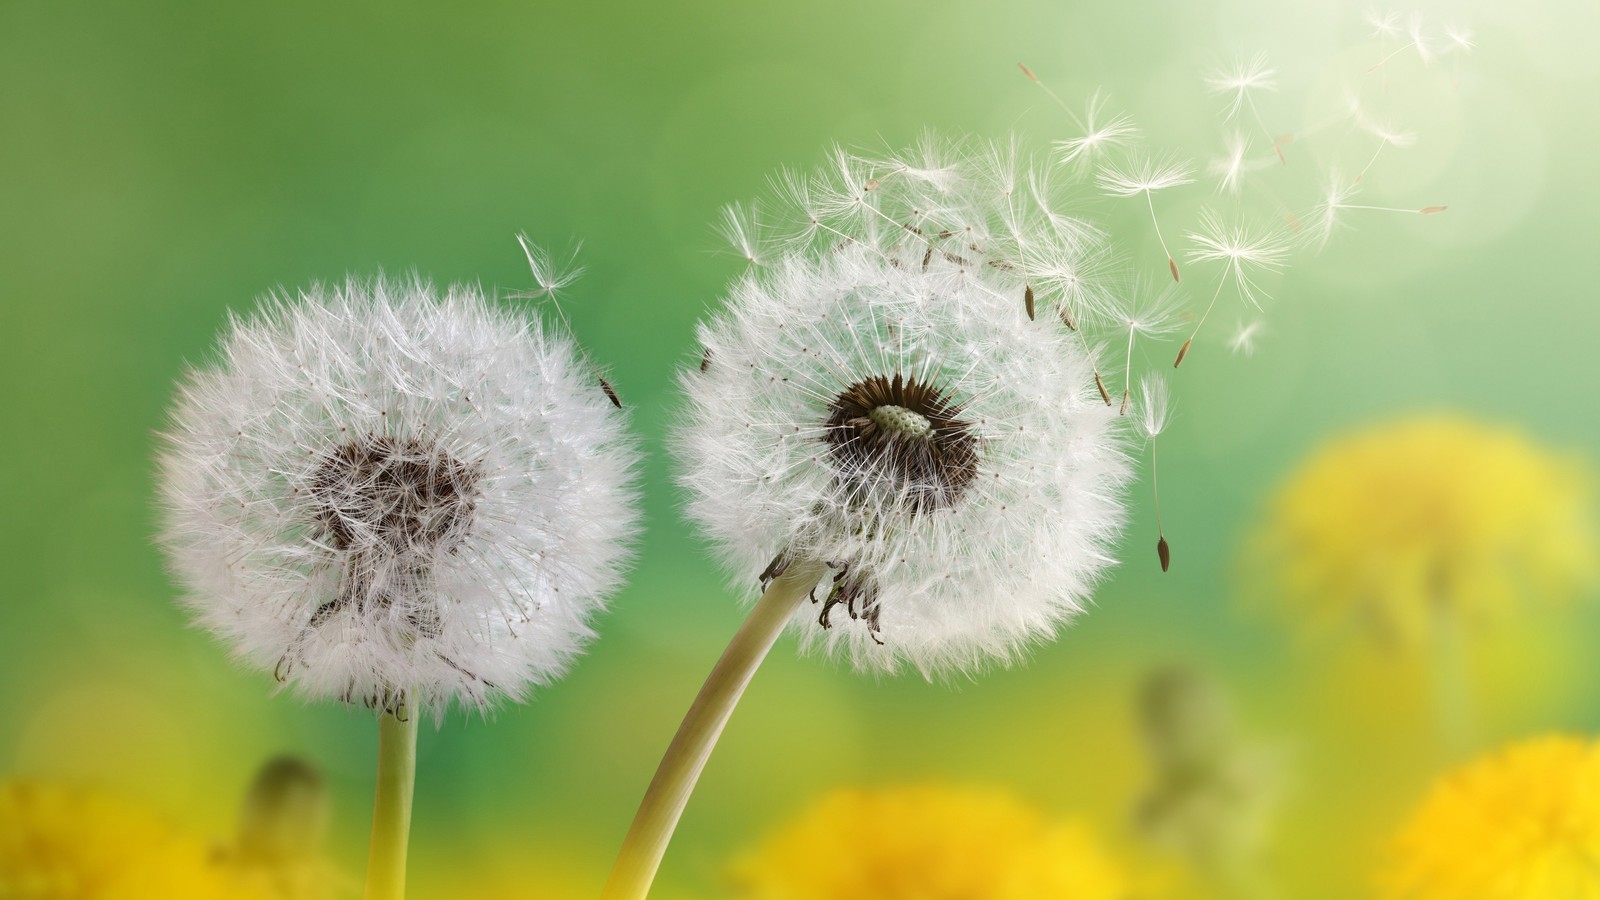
602, 560, 824, 900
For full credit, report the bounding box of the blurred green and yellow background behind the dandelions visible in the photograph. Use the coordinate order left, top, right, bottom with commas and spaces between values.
0, 0, 1600, 898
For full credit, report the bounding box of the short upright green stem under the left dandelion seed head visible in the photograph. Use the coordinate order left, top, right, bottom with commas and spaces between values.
366, 706, 418, 900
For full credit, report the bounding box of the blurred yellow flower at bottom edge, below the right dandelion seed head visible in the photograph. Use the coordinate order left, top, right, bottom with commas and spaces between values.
733, 785, 1131, 900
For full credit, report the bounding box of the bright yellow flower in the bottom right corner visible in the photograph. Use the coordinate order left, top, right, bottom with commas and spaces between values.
1379, 737, 1600, 900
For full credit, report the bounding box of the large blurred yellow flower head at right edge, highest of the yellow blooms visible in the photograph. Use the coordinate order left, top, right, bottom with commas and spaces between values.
1250, 415, 1597, 645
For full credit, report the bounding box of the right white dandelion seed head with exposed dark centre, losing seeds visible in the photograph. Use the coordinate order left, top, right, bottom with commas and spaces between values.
677, 141, 1128, 677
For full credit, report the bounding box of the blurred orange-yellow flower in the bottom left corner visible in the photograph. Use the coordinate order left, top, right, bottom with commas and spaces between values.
0, 780, 344, 900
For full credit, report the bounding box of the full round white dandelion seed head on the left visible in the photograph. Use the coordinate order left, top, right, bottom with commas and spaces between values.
160, 275, 637, 714
